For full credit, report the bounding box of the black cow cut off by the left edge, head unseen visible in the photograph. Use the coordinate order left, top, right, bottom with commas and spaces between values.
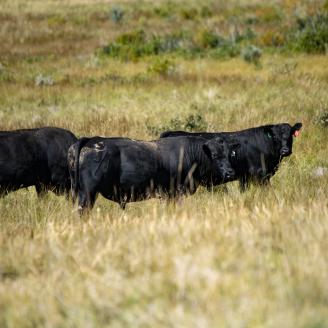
0, 127, 77, 196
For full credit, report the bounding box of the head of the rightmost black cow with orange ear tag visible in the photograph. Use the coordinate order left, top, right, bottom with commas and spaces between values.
264, 123, 302, 157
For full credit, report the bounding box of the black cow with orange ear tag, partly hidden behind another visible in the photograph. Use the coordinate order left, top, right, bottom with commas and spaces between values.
160, 123, 302, 191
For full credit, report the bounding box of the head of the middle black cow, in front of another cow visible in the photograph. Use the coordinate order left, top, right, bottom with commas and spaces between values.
203, 137, 240, 184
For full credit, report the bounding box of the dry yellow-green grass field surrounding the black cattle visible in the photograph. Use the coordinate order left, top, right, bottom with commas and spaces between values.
0, 0, 328, 328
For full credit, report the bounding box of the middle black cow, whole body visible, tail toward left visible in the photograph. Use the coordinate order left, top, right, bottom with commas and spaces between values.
68, 137, 238, 214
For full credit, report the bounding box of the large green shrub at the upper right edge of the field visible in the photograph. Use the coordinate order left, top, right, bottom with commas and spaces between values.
295, 14, 328, 53
